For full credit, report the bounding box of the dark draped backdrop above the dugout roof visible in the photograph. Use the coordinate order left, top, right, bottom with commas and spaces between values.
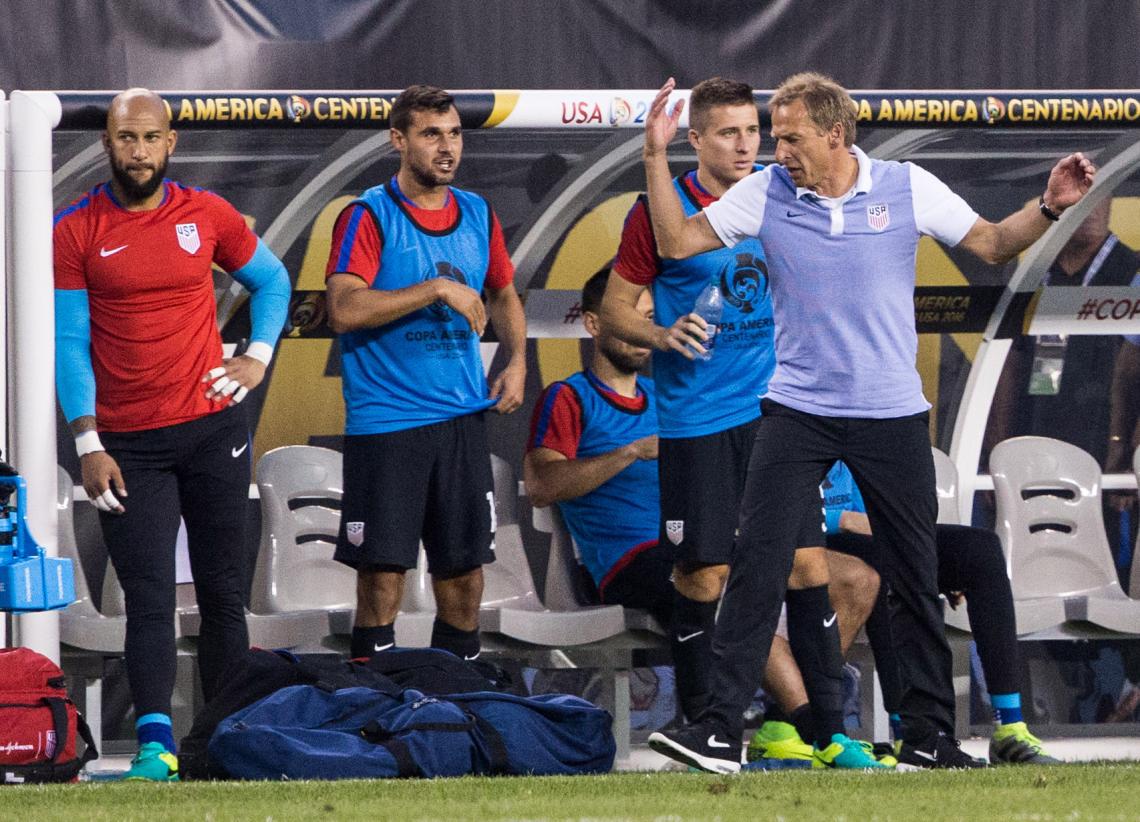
0, 0, 1140, 90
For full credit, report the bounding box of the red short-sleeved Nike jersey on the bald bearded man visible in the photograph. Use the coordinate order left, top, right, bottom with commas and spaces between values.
52, 180, 258, 431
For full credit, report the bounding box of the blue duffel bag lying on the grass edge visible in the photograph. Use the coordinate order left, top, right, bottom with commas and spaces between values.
209, 685, 616, 780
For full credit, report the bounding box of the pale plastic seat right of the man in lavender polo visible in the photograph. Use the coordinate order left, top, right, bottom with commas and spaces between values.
990, 437, 1140, 634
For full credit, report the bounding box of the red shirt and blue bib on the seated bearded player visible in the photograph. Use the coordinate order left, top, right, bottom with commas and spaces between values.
527, 371, 661, 589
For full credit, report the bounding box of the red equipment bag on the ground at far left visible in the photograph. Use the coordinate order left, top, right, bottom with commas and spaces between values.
0, 648, 99, 784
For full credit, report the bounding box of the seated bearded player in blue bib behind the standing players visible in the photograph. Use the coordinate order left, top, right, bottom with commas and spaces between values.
523, 269, 686, 693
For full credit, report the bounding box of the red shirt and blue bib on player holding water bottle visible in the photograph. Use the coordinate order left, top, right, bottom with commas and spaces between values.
613, 171, 776, 438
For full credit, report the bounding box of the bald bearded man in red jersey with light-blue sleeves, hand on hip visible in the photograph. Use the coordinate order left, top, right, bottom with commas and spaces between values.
54, 89, 291, 781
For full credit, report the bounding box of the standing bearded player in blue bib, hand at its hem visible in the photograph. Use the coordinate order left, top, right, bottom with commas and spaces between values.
326, 86, 526, 659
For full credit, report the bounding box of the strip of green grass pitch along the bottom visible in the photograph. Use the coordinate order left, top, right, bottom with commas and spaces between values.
0, 763, 1140, 822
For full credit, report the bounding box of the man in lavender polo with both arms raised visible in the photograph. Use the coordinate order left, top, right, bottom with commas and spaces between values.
644, 73, 1096, 773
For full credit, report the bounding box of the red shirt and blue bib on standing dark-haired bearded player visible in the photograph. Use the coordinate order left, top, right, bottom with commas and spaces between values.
326, 178, 514, 434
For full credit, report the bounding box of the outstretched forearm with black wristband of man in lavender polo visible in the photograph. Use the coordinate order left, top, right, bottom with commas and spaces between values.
961, 152, 1097, 263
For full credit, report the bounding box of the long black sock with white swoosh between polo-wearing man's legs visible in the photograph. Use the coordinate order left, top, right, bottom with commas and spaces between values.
787, 585, 844, 749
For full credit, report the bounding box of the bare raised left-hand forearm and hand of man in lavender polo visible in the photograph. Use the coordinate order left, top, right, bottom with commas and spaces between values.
642, 78, 724, 259
